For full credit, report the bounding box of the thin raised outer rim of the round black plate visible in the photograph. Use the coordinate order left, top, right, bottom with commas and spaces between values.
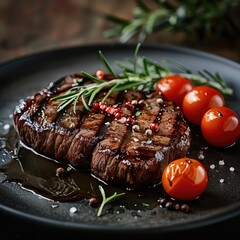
0, 43, 240, 233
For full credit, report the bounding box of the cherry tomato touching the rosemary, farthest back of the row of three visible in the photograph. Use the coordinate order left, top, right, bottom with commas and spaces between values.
156, 75, 193, 107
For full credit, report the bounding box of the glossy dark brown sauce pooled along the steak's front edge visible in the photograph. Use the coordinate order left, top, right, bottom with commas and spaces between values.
0, 125, 169, 210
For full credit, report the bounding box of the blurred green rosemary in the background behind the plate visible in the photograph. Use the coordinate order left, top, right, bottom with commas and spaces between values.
104, 0, 240, 42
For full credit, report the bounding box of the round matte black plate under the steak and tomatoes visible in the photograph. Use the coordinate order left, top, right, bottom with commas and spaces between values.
0, 44, 240, 234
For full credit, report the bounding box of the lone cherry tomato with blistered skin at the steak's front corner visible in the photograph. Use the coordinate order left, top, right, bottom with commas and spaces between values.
162, 157, 208, 200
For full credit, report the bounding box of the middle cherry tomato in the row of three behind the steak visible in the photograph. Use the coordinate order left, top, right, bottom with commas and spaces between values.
182, 85, 225, 126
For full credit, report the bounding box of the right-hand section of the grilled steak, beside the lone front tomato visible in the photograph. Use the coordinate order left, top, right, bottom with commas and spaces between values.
91, 91, 191, 188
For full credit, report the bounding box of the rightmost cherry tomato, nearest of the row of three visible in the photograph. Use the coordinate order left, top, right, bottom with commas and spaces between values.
201, 107, 240, 147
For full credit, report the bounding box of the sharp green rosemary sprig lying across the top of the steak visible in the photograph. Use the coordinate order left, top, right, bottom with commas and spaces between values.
51, 43, 233, 112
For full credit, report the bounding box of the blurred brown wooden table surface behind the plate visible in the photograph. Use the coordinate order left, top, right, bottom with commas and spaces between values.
0, 0, 240, 63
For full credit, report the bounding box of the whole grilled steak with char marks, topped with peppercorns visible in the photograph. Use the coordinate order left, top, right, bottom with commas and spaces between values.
14, 74, 191, 187
